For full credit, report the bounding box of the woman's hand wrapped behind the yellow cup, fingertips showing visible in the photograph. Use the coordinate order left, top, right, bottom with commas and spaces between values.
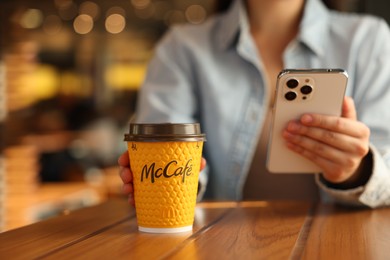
118, 151, 206, 206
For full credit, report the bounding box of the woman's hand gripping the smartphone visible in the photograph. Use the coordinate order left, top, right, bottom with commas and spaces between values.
283, 97, 370, 183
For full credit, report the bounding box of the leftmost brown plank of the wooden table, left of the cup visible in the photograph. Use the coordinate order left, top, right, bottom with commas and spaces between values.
0, 200, 135, 259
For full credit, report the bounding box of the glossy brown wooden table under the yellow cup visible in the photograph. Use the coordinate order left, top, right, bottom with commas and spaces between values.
0, 200, 390, 260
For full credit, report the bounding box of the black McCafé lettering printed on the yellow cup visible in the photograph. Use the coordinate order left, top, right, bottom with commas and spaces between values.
141, 159, 192, 183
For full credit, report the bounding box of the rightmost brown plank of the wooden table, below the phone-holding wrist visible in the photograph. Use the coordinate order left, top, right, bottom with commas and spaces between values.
302, 205, 390, 260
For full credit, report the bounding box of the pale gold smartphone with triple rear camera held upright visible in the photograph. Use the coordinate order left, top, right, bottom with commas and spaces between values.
267, 69, 348, 173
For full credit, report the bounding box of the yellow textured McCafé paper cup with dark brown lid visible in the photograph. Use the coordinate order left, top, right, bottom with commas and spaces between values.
125, 124, 205, 233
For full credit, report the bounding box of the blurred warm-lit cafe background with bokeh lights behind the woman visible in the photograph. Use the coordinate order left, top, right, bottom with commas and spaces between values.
0, 0, 390, 232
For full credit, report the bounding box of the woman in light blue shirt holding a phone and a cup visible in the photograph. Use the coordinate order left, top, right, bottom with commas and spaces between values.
119, 0, 390, 207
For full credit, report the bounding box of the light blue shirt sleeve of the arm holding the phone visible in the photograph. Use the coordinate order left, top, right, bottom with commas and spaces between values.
316, 19, 390, 208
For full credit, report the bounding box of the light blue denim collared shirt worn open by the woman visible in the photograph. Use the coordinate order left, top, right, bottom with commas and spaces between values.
136, 0, 390, 207
